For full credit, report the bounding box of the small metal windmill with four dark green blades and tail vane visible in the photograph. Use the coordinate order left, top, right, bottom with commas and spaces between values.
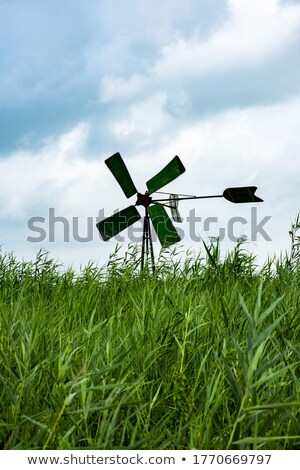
96, 152, 263, 271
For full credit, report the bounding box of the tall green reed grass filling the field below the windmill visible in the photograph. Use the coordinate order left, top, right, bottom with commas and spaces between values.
0, 218, 300, 449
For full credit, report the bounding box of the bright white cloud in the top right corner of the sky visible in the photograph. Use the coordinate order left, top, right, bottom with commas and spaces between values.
153, 0, 300, 80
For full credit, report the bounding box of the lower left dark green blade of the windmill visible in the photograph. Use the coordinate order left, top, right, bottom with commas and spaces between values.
96, 206, 141, 241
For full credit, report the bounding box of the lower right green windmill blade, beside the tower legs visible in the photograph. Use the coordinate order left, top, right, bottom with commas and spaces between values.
148, 204, 181, 248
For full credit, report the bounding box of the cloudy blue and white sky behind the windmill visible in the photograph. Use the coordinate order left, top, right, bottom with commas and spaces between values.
0, 0, 300, 269
